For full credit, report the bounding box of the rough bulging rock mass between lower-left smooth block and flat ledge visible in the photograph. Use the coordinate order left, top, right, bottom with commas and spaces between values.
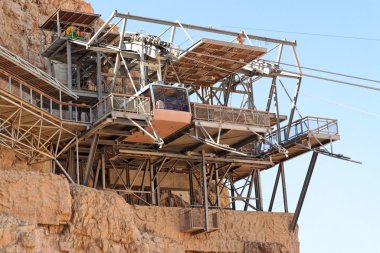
61, 185, 184, 253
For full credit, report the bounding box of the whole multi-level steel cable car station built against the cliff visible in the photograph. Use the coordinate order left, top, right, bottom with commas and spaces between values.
0, 10, 350, 232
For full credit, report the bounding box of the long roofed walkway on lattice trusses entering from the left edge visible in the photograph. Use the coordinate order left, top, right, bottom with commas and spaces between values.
0, 47, 90, 166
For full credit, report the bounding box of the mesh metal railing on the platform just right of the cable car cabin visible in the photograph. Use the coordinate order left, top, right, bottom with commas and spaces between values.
191, 103, 270, 127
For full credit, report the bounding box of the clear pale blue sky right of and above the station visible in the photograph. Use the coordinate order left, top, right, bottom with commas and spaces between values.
90, 0, 380, 253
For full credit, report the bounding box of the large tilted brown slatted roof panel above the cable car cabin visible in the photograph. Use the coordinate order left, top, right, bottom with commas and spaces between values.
166, 39, 267, 86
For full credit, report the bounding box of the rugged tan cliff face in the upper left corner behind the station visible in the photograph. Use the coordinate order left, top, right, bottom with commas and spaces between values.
0, 0, 93, 68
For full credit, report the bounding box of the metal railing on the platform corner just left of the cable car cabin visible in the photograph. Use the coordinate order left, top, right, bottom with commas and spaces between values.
91, 93, 152, 122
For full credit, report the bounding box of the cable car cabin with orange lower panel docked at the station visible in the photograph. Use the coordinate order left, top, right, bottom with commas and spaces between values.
125, 84, 191, 143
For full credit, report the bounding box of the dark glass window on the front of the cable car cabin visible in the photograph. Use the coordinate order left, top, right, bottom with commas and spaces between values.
153, 85, 190, 112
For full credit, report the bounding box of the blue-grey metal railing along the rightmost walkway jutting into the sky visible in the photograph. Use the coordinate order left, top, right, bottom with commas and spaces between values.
240, 116, 339, 154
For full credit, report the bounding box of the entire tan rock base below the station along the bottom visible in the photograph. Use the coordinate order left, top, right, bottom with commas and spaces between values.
0, 171, 299, 253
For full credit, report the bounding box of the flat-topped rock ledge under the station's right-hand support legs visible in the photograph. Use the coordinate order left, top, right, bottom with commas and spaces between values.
133, 206, 299, 253
